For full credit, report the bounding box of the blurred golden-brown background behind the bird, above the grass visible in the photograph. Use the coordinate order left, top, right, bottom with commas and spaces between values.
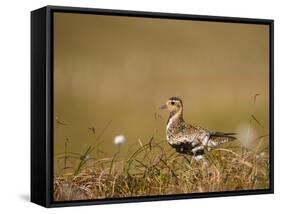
54, 12, 269, 172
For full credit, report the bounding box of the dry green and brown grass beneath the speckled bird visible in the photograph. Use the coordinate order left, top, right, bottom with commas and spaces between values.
54, 96, 270, 201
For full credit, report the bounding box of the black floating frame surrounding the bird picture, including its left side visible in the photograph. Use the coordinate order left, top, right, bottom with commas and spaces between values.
31, 6, 274, 207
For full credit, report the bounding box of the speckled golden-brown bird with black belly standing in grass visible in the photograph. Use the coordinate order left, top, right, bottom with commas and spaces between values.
160, 97, 236, 160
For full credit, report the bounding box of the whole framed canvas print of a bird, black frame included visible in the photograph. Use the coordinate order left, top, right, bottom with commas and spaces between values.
31, 6, 274, 207
